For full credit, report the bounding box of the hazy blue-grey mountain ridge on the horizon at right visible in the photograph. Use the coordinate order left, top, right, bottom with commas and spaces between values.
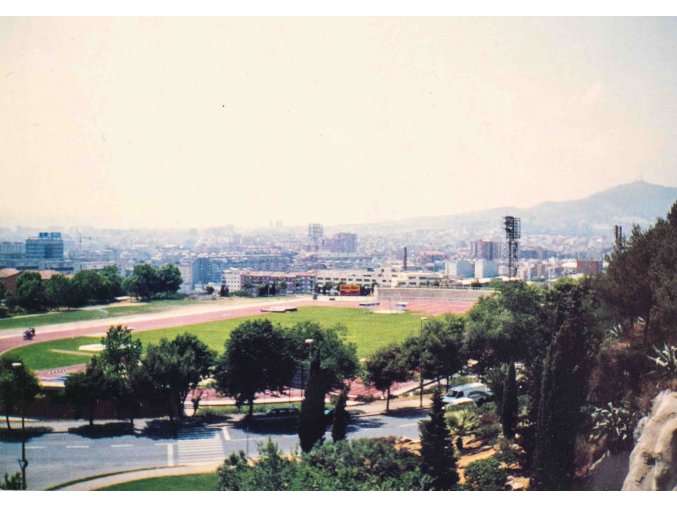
352, 181, 677, 235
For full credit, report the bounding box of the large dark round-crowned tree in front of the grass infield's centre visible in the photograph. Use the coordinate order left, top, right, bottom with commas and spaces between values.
216, 319, 302, 416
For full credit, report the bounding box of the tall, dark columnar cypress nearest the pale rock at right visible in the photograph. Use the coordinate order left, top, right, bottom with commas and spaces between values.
533, 284, 599, 491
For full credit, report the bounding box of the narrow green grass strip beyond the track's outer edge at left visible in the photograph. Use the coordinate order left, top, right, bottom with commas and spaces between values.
0, 299, 198, 329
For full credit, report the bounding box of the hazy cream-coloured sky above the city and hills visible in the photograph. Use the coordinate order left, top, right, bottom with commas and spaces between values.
0, 18, 677, 227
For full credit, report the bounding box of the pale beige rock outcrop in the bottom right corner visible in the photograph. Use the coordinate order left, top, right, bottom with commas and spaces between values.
623, 391, 677, 491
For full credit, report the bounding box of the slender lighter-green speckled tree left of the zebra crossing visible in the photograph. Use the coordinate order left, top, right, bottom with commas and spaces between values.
99, 325, 142, 423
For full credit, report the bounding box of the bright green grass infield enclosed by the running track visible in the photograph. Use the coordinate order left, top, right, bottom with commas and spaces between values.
5, 307, 420, 370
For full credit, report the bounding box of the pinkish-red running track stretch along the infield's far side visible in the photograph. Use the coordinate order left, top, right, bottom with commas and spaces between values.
0, 301, 475, 364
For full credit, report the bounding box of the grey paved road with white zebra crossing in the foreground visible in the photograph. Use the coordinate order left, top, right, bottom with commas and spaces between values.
0, 412, 426, 490
